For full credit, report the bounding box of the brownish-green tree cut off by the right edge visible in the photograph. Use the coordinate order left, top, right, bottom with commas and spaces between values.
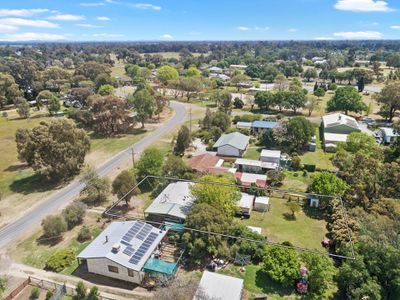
375, 81, 400, 122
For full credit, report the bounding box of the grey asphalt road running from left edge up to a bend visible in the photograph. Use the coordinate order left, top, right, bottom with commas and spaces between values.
0, 102, 187, 250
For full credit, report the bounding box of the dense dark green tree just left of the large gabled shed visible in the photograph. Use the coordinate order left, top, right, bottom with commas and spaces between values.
287, 117, 315, 150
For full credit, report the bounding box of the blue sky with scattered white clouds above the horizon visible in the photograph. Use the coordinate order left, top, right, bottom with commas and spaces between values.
0, 0, 400, 42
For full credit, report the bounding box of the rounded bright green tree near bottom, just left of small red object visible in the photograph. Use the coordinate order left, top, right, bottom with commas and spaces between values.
262, 246, 300, 287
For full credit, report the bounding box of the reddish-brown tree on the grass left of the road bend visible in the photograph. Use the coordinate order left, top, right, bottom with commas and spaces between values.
90, 96, 133, 136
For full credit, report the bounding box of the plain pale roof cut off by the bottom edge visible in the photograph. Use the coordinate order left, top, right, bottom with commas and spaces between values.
193, 271, 243, 300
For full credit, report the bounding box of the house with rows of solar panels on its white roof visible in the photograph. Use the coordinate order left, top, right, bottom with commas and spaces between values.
77, 221, 167, 284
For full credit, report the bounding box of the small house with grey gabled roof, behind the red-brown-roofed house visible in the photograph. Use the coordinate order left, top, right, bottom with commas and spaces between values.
214, 132, 250, 157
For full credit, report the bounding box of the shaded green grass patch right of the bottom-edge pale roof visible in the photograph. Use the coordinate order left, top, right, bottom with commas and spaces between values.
218, 265, 300, 300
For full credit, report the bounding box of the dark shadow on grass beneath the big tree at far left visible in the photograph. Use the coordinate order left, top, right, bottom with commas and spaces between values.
10, 174, 60, 195
